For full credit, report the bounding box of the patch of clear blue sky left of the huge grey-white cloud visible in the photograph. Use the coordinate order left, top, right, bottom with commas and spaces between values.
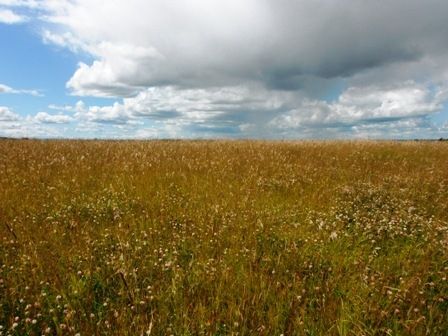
0, 21, 118, 137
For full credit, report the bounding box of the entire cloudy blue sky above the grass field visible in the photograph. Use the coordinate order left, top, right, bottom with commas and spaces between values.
0, 0, 448, 139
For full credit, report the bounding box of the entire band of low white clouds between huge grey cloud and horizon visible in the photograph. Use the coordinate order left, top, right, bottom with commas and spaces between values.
51, 81, 441, 138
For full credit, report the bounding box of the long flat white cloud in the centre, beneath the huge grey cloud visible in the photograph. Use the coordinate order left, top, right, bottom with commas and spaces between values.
71, 86, 297, 123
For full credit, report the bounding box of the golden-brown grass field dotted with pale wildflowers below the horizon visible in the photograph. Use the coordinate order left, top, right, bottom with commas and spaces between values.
0, 140, 448, 335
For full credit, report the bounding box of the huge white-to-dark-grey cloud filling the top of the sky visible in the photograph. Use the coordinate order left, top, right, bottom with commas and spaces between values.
26, 0, 448, 96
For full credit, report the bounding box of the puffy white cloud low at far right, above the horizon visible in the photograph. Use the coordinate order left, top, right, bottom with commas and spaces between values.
271, 82, 442, 129
